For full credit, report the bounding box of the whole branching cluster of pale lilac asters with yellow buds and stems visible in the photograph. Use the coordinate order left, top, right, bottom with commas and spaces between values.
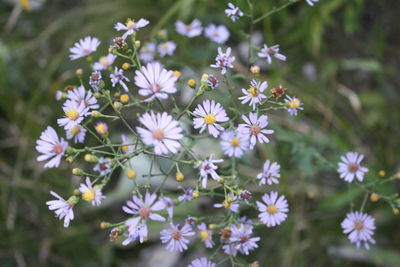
36, 0, 398, 267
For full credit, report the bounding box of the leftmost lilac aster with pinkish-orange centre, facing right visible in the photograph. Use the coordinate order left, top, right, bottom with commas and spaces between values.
36, 126, 68, 168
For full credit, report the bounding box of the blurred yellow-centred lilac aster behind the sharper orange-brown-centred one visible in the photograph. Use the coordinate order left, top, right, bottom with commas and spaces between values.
219, 130, 249, 158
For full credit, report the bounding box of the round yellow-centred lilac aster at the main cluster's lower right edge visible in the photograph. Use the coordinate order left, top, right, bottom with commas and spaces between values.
256, 191, 289, 227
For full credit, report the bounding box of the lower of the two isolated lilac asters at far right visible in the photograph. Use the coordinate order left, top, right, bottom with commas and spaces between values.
341, 211, 375, 249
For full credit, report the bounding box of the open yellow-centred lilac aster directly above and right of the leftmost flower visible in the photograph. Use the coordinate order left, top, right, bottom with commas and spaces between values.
57, 100, 89, 130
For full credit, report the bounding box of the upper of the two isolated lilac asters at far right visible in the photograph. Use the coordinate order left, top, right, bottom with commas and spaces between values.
337, 152, 368, 183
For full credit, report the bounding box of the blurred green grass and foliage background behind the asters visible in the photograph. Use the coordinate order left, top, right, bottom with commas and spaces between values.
0, 0, 400, 267
